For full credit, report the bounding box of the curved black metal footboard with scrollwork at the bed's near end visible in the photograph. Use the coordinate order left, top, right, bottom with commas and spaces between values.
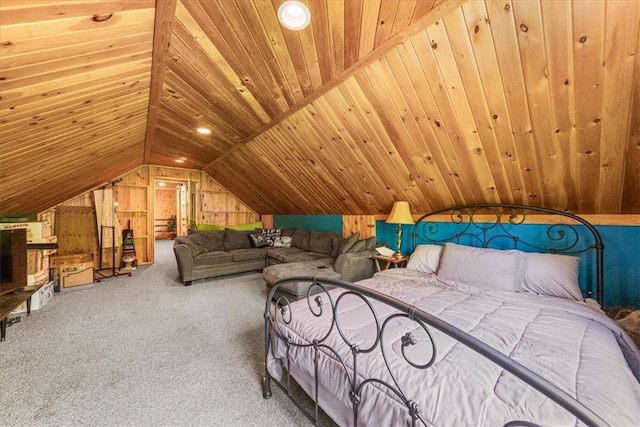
263, 277, 607, 426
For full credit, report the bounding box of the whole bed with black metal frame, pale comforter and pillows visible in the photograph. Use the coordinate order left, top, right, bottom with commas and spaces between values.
263, 204, 640, 426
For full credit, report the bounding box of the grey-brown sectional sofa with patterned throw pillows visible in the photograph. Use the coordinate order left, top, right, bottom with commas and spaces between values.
173, 228, 376, 286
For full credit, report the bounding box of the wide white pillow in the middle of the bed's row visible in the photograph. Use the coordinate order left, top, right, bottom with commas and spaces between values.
437, 243, 524, 291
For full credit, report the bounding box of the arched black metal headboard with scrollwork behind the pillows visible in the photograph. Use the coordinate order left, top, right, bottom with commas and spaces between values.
412, 203, 604, 306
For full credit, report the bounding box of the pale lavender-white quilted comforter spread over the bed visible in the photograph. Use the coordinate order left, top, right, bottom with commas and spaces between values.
267, 269, 640, 426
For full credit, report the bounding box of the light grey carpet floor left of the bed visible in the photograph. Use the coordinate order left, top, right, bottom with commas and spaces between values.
0, 241, 316, 426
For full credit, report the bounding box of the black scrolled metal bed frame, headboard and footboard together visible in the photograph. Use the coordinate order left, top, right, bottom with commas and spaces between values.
262, 204, 607, 427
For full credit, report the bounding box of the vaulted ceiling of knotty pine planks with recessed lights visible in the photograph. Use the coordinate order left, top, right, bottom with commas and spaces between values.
0, 0, 640, 214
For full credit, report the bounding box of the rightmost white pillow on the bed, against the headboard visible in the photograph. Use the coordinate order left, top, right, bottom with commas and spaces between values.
522, 252, 584, 301
